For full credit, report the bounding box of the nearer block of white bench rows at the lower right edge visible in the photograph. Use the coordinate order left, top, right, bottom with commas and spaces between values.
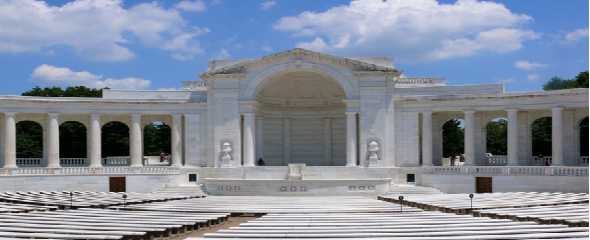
472, 204, 590, 227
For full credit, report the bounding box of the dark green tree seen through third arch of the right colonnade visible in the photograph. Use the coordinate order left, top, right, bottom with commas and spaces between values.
532, 117, 553, 156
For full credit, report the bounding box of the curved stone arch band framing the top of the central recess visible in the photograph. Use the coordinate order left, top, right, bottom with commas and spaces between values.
241, 63, 359, 101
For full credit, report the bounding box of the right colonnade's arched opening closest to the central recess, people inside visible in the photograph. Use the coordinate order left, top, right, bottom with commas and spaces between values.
442, 119, 465, 166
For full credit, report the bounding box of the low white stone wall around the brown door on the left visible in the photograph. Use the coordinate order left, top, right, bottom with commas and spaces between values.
0, 174, 179, 193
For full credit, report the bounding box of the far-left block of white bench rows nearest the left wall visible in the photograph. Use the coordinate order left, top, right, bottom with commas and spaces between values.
0, 192, 201, 208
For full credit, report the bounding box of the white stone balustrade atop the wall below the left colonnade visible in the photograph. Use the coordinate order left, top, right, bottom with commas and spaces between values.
0, 167, 180, 176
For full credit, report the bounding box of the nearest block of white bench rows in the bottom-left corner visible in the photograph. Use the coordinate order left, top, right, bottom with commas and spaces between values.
0, 209, 229, 240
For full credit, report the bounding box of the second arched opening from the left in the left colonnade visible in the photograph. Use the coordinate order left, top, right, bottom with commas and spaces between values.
59, 121, 89, 167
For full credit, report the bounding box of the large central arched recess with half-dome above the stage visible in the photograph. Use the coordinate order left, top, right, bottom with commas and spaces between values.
254, 71, 346, 166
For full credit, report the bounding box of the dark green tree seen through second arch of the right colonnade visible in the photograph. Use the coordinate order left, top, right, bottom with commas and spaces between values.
486, 119, 508, 156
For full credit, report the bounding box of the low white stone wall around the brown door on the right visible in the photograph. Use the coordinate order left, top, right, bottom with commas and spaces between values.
422, 174, 590, 193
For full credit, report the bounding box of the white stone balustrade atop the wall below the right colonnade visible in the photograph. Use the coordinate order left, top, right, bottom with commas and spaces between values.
424, 166, 590, 176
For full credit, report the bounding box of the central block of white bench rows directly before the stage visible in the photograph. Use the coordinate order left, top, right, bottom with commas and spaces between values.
110, 196, 422, 216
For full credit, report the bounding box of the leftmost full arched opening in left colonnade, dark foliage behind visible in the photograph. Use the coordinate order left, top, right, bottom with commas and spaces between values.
16, 121, 44, 167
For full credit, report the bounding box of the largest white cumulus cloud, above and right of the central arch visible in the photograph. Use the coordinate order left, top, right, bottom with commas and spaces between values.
274, 0, 540, 61
